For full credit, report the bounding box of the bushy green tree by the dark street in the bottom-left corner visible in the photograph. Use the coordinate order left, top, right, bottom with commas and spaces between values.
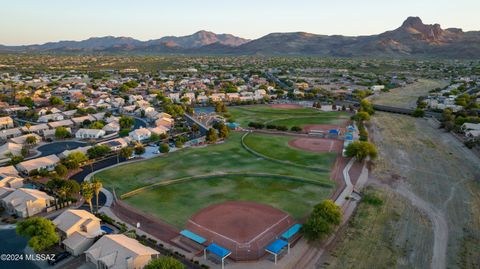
16, 217, 60, 252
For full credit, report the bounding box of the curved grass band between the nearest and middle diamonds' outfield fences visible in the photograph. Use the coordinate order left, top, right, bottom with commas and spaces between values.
96, 132, 333, 196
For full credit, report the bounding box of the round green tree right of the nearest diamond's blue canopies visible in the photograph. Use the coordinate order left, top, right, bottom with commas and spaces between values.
303, 200, 342, 241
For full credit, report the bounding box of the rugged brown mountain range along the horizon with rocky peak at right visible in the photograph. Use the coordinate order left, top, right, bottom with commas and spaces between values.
0, 17, 480, 59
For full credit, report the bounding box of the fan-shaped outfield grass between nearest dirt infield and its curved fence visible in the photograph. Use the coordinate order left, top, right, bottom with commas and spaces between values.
125, 176, 330, 228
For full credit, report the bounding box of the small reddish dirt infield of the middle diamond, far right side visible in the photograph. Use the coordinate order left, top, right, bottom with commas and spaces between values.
288, 137, 343, 153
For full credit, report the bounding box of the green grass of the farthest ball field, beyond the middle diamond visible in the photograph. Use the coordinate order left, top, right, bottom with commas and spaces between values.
228, 105, 349, 128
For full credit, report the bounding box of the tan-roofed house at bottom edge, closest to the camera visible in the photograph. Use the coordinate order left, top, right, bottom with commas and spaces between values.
85, 234, 160, 269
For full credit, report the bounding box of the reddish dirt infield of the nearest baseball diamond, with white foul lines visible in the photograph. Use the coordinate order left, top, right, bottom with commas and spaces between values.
185, 201, 296, 261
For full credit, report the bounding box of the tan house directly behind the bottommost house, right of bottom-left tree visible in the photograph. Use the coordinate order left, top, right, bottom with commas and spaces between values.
53, 209, 103, 256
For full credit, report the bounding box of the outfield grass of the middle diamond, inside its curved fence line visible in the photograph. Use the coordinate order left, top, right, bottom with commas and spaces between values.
244, 133, 336, 169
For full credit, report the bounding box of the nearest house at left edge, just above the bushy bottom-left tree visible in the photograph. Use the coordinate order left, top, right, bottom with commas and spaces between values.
0, 188, 55, 218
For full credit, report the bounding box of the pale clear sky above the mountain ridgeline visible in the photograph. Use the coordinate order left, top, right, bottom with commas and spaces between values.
0, 0, 480, 45
